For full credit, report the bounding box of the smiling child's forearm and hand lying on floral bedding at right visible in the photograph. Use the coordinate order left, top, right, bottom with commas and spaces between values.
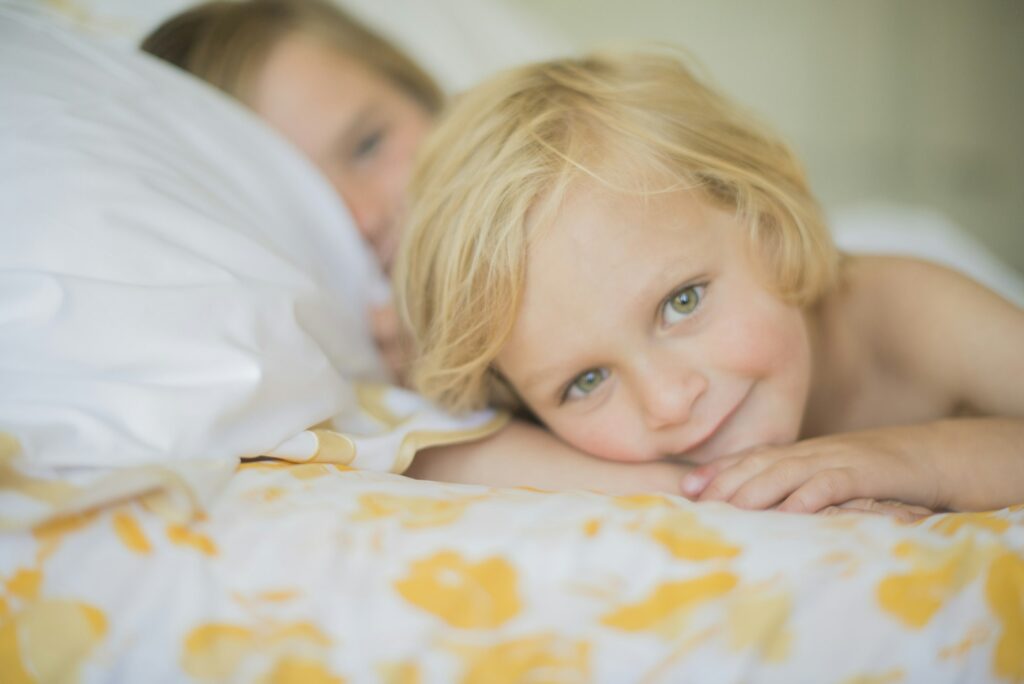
683, 418, 1024, 513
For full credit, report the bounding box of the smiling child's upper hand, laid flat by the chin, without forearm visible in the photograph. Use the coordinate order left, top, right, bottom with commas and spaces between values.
682, 430, 945, 513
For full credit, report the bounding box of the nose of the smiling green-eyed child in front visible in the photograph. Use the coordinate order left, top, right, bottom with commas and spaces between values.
637, 359, 708, 430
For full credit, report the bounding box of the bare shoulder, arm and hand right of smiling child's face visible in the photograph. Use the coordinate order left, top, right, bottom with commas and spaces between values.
683, 253, 1024, 512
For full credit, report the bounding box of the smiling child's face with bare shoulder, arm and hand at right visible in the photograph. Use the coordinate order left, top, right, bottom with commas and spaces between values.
496, 184, 1024, 512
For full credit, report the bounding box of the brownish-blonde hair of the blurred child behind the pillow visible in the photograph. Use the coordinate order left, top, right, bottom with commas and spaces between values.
140, 0, 443, 114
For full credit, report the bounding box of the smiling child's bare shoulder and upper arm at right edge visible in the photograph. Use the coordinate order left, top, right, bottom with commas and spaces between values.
842, 256, 1024, 413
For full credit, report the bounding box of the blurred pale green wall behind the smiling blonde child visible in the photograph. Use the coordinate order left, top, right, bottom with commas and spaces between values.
512, 0, 1024, 271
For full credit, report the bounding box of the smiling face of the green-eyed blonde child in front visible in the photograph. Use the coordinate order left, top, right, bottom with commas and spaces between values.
497, 185, 811, 463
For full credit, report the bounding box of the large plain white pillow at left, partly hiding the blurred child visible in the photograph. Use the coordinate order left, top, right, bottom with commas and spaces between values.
0, 3, 386, 468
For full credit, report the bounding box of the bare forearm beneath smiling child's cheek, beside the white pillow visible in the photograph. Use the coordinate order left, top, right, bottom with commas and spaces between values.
406, 421, 692, 496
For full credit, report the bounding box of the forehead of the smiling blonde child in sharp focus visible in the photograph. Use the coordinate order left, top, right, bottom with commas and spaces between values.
498, 183, 739, 372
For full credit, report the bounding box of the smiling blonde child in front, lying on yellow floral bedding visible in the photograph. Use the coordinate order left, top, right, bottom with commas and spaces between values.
395, 55, 1024, 512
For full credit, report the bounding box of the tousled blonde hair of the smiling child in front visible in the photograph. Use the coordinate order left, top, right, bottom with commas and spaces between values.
395, 54, 838, 411
